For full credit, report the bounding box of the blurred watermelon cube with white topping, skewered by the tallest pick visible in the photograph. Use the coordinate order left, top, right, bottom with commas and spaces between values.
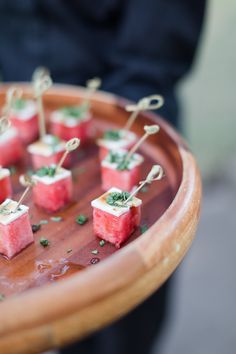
27, 135, 70, 170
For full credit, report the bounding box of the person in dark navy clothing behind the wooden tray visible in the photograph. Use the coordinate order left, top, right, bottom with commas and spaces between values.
0, 0, 205, 354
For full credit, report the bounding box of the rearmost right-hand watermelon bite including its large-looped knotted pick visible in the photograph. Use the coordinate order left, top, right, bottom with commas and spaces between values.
97, 95, 164, 161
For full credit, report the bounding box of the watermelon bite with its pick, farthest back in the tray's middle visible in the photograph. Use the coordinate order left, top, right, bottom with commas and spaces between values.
50, 78, 101, 144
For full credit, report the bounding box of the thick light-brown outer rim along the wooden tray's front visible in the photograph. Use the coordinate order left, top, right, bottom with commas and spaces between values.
0, 142, 201, 353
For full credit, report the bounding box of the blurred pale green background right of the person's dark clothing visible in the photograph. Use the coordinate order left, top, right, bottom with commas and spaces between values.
179, 0, 236, 178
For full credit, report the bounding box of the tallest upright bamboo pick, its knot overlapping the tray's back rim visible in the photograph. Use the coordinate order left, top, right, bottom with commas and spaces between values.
33, 71, 52, 140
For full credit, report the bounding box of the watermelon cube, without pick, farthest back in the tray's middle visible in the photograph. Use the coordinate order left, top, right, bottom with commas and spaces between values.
50, 106, 92, 144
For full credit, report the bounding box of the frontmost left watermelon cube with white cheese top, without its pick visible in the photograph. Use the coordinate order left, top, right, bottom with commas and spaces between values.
0, 199, 34, 259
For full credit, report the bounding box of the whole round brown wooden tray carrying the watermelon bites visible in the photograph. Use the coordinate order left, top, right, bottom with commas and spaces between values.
0, 84, 201, 354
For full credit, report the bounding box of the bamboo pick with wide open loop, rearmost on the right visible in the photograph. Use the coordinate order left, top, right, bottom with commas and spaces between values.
123, 95, 164, 131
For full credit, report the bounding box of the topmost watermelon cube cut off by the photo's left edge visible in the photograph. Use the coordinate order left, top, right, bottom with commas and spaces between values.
0, 127, 23, 167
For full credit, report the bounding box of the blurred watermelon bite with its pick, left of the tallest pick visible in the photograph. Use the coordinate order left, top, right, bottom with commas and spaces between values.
6, 87, 38, 144
